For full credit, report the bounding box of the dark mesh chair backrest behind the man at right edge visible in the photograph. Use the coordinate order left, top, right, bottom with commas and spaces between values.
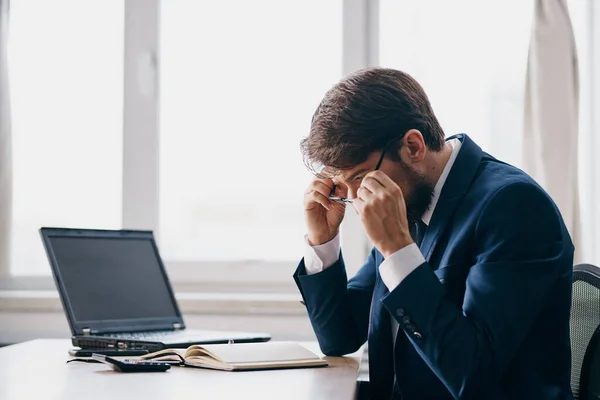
570, 264, 600, 400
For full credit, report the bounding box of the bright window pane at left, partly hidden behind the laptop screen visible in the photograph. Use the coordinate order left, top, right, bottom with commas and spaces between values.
9, 0, 124, 275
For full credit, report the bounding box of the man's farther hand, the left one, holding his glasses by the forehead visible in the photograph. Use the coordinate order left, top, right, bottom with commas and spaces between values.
304, 178, 346, 246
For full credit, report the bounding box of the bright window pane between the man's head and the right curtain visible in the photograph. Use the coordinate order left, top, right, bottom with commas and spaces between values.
380, 0, 533, 165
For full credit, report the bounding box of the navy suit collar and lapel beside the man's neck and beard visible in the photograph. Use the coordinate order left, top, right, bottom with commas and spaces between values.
420, 134, 483, 260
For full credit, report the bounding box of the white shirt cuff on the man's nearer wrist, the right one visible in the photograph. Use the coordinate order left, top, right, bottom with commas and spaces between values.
379, 243, 425, 292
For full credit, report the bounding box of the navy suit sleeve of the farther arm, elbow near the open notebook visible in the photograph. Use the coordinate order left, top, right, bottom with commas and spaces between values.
294, 250, 375, 356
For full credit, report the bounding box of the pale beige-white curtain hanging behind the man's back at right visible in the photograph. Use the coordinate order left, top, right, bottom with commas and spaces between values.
523, 0, 581, 263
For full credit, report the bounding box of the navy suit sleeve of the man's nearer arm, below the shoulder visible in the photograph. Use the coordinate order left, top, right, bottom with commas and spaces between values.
382, 183, 573, 399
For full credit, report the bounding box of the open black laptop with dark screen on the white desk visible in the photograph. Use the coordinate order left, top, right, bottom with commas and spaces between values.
40, 227, 271, 352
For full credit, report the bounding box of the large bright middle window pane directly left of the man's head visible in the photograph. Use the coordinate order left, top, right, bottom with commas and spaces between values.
160, 0, 342, 262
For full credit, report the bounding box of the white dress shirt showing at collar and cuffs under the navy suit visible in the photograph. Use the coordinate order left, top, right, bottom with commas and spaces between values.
304, 139, 462, 341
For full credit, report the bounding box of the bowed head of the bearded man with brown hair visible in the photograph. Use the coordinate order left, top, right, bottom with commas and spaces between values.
301, 68, 444, 219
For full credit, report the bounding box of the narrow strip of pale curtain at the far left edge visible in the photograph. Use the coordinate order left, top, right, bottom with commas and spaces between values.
0, 0, 12, 275
